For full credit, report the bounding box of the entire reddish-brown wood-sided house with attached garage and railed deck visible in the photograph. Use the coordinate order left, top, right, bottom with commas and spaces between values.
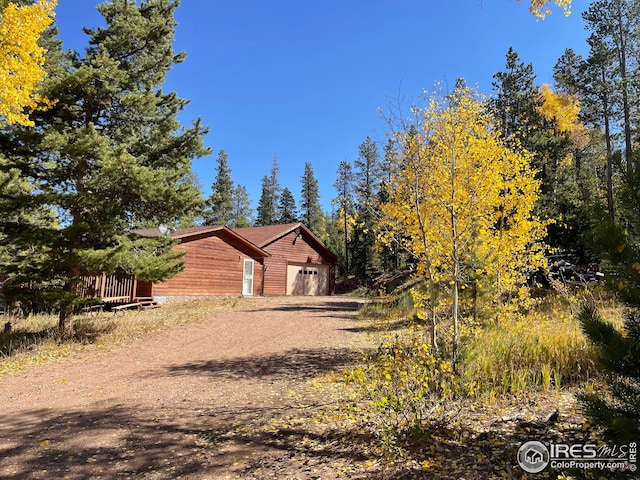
78, 223, 337, 303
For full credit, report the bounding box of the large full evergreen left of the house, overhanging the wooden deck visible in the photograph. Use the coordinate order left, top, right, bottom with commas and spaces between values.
0, 0, 208, 327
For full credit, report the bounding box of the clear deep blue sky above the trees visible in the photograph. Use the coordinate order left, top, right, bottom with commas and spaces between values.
56, 0, 589, 214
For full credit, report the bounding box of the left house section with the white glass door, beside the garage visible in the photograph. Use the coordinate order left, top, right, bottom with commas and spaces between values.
133, 226, 269, 298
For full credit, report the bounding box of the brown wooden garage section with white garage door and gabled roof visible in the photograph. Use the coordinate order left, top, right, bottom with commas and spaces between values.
234, 223, 338, 295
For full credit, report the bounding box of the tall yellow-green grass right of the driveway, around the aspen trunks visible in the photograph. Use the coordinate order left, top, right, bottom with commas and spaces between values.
361, 291, 624, 398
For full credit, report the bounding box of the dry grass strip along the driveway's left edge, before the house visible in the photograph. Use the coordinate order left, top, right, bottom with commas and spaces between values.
0, 297, 255, 376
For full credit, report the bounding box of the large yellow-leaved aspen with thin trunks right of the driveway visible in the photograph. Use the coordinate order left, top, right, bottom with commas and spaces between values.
380, 81, 546, 359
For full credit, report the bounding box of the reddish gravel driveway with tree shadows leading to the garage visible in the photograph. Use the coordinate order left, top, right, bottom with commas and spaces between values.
0, 297, 362, 480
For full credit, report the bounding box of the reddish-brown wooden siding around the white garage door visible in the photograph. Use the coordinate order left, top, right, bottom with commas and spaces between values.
263, 231, 334, 295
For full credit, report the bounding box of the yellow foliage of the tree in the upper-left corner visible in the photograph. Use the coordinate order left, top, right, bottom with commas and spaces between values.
0, 0, 56, 126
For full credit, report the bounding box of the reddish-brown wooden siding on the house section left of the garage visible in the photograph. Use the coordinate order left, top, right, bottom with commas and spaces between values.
153, 233, 263, 296
